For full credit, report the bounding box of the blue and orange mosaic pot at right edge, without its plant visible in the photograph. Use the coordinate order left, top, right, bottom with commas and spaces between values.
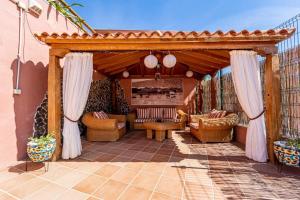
274, 141, 300, 167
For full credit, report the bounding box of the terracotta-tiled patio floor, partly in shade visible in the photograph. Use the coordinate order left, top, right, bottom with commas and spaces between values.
0, 131, 300, 200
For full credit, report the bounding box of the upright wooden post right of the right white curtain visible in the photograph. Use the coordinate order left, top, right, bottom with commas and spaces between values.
265, 54, 281, 163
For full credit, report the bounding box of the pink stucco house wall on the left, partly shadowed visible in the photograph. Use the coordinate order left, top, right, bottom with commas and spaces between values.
0, 0, 78, 168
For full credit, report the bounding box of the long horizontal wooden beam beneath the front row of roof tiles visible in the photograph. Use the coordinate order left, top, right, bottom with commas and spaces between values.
51, 40, 275, 51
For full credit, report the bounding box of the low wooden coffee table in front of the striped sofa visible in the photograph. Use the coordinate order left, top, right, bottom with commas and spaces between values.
143, 122, 178, 142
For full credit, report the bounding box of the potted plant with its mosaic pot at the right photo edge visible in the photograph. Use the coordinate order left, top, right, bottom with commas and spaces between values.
274, 138, 300, 167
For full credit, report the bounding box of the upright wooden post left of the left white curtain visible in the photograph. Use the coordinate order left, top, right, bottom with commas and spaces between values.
48, 53, 62, 161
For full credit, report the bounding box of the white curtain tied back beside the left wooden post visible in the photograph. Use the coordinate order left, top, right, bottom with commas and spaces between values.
62, 53, 93, 159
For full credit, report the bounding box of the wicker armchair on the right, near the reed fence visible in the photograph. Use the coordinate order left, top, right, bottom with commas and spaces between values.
190, 113, 239, 143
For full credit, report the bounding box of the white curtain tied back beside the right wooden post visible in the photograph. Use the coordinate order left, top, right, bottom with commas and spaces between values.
230, 50, 268, 162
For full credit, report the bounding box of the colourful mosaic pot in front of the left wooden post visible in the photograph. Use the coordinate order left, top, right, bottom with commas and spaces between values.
27, 139, 56, 162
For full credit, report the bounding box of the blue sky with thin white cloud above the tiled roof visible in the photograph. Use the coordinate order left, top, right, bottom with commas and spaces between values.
67, 0, 300, 31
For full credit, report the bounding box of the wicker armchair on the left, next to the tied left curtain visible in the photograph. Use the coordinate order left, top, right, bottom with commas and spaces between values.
82, 113, 126, 141
